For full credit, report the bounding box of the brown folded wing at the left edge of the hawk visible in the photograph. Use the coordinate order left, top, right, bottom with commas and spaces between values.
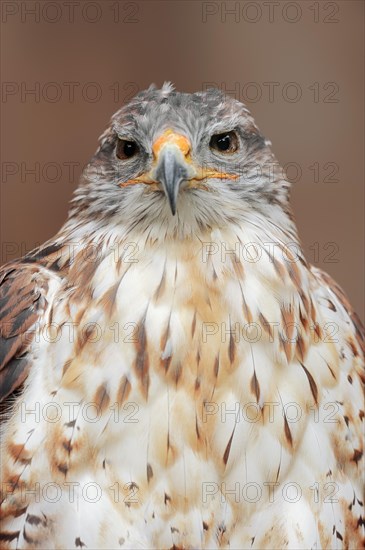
0, 242, 69, 404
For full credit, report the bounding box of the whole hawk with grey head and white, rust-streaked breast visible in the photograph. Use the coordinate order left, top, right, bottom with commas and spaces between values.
0, 84, 364, 550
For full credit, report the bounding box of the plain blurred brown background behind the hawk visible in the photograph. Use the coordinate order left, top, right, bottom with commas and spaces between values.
1, 0, 364, 318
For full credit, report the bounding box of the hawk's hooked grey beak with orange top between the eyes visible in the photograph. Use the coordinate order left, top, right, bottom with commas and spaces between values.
152, 130, 196, 216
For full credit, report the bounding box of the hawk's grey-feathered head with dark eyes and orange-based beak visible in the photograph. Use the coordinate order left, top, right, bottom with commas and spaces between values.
71, 83, 290, 236
